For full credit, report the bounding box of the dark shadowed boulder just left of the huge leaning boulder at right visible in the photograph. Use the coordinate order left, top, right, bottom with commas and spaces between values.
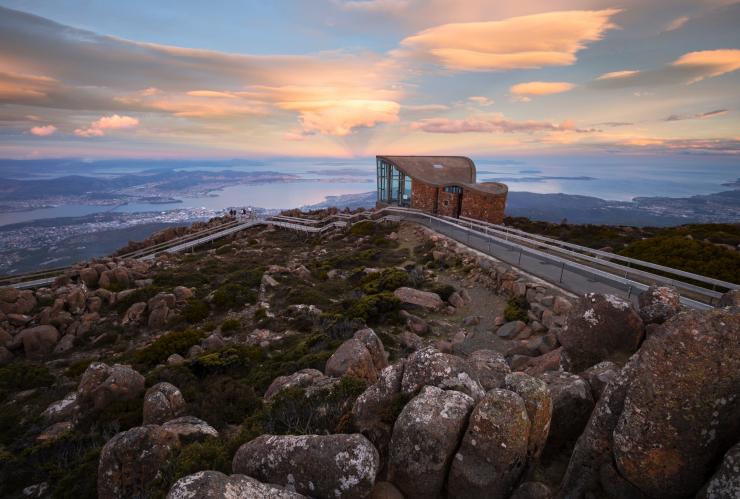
540, 371, 594, 457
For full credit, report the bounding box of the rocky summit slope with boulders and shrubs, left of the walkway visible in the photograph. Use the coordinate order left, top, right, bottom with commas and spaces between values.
0, 211, 740, 499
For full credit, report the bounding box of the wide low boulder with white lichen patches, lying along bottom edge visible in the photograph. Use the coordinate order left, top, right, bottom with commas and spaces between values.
232, 434, 378, 499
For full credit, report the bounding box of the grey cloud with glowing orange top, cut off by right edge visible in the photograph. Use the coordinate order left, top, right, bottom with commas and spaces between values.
591, 49, 740, 88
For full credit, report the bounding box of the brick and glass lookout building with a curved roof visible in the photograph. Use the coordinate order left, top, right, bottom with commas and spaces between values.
376, 156, 508, 224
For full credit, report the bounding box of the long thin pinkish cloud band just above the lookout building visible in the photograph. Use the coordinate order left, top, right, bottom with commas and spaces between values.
411, 113, 595, 134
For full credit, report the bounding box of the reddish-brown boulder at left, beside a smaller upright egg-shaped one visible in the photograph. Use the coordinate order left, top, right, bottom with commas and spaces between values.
77, 362, 145, 410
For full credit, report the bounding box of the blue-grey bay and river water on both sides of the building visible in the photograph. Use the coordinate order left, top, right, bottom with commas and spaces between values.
0, 156, 740, 226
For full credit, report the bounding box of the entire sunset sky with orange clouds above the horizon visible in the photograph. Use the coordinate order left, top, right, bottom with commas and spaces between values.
0, 0, 740, 159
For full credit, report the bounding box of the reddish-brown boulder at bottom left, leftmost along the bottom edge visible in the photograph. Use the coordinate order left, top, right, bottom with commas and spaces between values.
98, 425, 180, 499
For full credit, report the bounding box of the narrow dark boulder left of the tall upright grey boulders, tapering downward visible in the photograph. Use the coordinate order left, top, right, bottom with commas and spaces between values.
352, 360, 405, 470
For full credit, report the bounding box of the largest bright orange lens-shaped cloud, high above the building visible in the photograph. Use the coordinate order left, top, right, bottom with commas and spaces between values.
394, 9, 619, 71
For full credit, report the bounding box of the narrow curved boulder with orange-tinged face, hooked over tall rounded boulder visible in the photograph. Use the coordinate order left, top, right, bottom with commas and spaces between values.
503, 373, 552, 464
